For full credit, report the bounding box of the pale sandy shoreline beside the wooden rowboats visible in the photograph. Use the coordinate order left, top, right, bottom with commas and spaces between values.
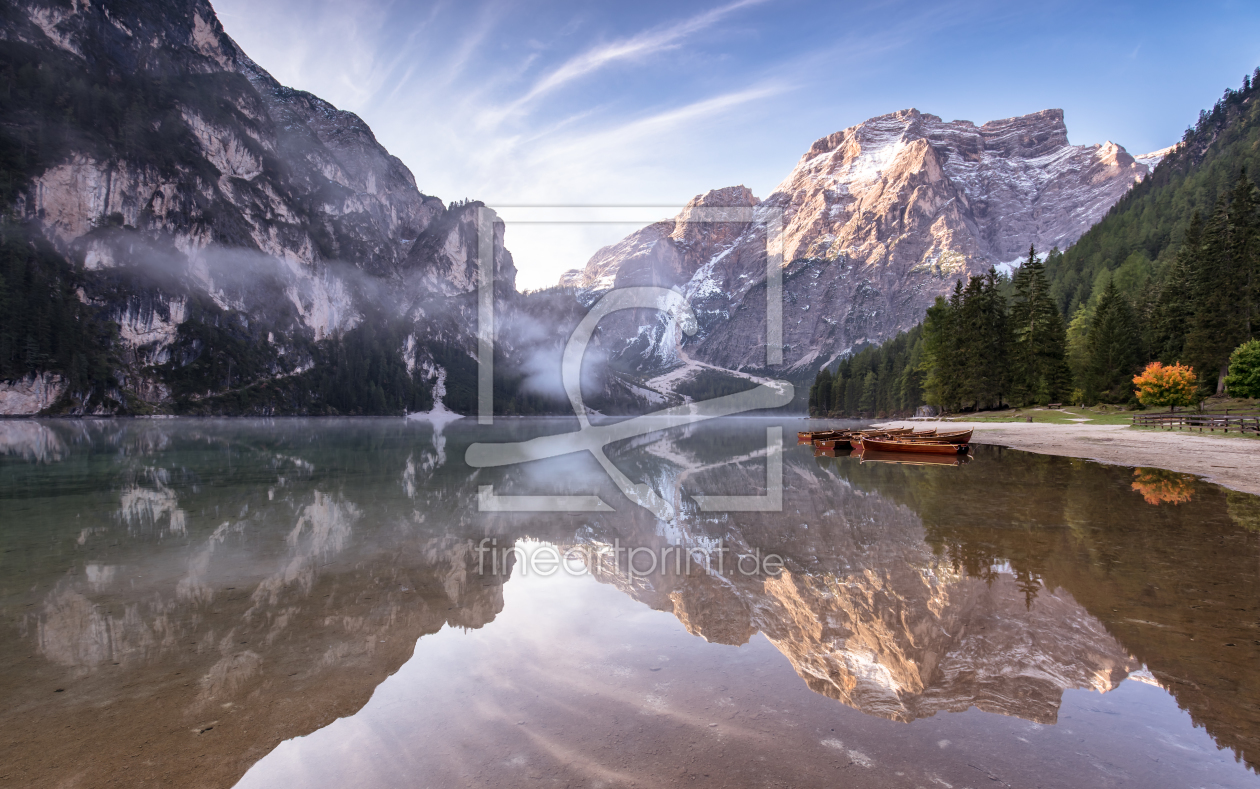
887, 422, 1260, 495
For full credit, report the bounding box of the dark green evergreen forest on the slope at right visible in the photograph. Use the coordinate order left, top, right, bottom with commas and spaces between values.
809, 68, 1260, 416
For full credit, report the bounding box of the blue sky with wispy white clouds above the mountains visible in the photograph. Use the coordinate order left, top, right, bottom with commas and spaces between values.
214, 0, 1260, 287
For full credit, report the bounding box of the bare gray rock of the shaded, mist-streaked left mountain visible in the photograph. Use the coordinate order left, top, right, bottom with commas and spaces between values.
0, 0, 515, 413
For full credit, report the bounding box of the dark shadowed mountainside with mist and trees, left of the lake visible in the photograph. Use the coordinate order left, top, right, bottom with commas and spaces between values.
0, 0, 515, 412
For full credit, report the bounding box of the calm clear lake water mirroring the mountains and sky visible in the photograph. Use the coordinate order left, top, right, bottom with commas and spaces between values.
0, 420, 1260, 786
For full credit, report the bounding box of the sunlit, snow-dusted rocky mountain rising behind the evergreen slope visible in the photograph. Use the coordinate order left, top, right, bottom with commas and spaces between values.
563, 110, 1159, 378
